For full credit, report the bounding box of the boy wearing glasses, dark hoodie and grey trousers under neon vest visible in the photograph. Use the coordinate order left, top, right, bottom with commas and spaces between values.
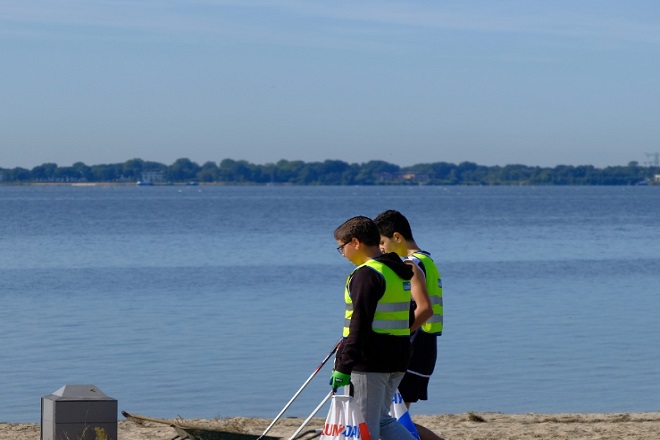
330, 216, 415, 440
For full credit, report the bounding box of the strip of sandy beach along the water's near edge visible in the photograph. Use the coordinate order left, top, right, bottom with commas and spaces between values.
5, 412, 660, 440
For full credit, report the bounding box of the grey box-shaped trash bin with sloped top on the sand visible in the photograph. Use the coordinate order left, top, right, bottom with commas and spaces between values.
41, 385, 117, 440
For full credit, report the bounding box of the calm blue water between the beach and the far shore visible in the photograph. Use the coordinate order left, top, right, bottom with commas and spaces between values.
0, 187, 660, 422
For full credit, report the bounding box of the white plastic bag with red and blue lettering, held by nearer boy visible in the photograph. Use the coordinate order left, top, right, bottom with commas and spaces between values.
321, 394, 371, 440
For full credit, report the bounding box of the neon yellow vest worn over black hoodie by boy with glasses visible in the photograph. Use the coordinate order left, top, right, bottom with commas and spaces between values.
343, 260, 410, 337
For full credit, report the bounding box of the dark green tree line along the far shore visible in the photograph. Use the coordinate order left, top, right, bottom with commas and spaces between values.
0, 158, 660, 185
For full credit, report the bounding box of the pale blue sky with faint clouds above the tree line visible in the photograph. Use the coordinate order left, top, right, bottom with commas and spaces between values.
0, 0, 660, 169
